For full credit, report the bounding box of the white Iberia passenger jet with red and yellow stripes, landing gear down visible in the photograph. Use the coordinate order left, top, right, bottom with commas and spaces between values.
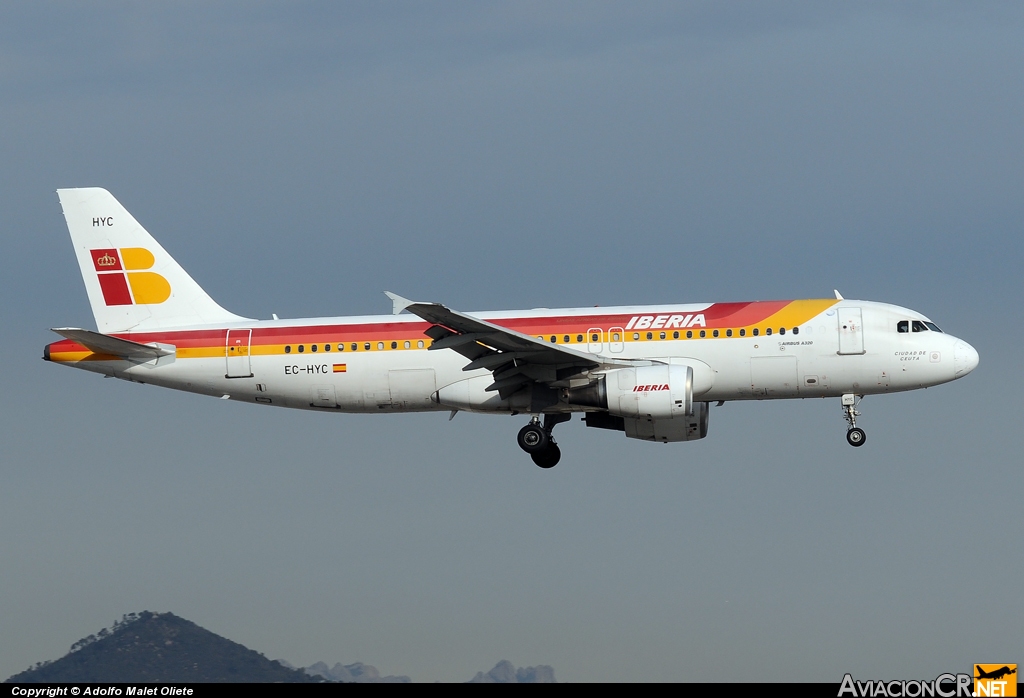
43, 187, 979, 468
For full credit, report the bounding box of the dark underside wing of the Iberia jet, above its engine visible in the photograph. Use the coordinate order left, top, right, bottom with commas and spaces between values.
385, 292, 630, 399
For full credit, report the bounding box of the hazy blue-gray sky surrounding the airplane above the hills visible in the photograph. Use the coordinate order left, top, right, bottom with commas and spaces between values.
0, 1, 1024, 682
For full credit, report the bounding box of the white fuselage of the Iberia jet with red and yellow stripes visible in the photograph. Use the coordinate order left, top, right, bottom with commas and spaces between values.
47, 300, 978, 412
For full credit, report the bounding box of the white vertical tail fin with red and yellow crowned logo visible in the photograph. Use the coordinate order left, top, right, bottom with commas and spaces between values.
57, 187, 246, 334
